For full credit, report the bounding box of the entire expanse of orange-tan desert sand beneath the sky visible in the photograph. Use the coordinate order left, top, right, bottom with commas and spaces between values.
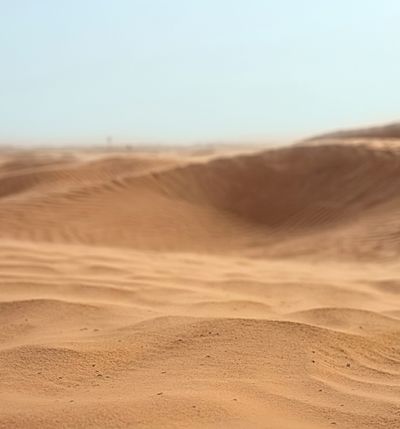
0, 138, 400, 429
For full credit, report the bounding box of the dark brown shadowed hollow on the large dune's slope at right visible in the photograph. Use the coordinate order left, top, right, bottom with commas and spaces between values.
154, 145, 400, 228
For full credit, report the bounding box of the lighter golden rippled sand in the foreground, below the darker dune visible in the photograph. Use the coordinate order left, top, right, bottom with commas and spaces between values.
0, 242, 400, 429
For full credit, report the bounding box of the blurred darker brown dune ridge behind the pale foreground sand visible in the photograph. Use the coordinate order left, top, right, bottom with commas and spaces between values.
0, 144, 400, 259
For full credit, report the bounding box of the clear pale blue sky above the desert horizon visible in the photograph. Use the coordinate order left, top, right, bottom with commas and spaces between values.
0, 0, 400, 143
